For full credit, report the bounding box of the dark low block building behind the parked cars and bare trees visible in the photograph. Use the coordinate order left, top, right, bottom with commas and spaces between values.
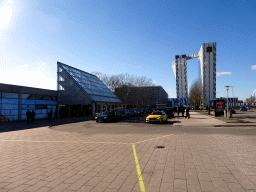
115, 86, 168, 108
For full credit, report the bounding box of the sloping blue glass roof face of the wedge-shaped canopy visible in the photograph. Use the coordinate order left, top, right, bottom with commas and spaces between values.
58, 62, 122, 103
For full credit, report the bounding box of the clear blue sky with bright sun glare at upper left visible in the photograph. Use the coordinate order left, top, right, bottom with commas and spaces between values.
0, 0, 256, 100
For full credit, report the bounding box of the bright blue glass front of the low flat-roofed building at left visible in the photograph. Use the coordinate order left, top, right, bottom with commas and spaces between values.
0, 92, 57, 121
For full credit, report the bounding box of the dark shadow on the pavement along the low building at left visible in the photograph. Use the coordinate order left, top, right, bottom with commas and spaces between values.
0, 117, 92, 133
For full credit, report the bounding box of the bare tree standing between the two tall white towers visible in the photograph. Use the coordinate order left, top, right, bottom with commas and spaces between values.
189, 79, 203, 108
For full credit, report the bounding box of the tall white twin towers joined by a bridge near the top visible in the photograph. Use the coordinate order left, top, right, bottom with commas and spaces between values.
172, 42, 216, 106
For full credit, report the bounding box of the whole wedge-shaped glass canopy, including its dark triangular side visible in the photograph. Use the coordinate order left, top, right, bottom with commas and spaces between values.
57, 62, 122, 105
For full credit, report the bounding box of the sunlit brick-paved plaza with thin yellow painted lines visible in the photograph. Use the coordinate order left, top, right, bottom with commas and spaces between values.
0, 112, 256, 192
